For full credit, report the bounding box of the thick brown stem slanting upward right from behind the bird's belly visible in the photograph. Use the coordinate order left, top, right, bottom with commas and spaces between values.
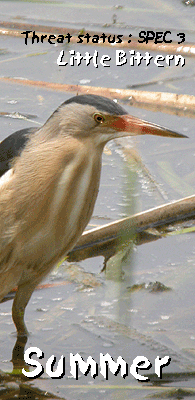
69, 195, 195, 261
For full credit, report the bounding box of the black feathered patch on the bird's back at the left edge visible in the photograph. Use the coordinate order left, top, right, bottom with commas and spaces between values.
0, 128, 37, 177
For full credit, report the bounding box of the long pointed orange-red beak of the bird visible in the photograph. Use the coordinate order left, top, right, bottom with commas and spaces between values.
108, 115, 188, 138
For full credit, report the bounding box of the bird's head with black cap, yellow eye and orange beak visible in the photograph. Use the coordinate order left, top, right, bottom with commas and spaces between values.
43, 94, 186, 145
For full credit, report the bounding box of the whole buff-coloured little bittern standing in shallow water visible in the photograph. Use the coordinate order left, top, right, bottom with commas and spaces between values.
0, 94, 184, 336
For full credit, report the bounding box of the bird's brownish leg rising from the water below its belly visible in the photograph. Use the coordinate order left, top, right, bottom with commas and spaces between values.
12, 279, 40, 337
